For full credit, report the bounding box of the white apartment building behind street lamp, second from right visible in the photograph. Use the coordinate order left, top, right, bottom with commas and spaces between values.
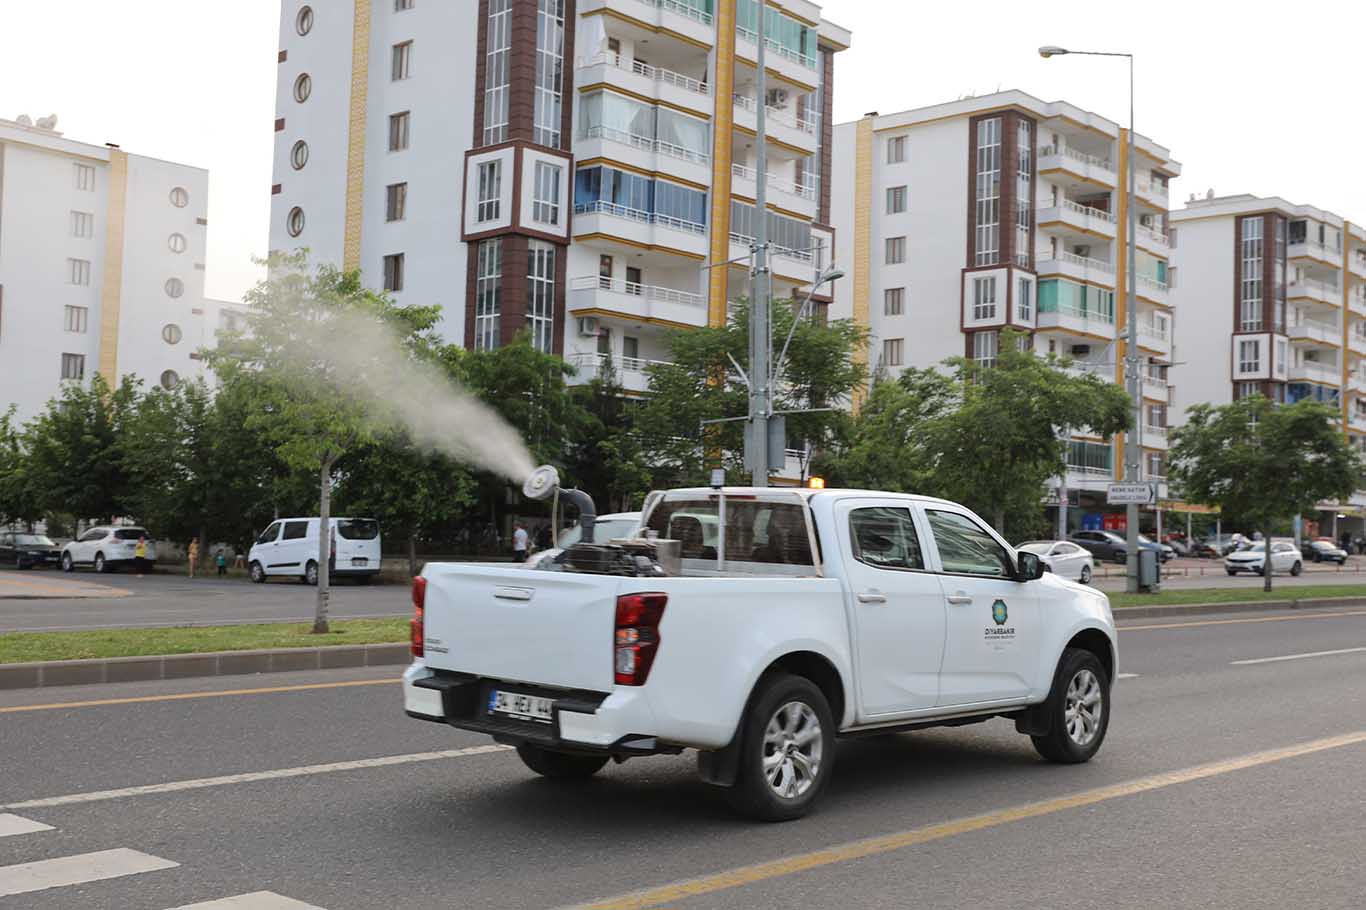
831, 92, 1180, 516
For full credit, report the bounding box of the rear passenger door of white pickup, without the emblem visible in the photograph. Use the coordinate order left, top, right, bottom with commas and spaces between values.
837, 499, 947, 723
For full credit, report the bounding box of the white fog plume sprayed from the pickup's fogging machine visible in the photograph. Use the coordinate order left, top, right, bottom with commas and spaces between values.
299, 313, 535, 485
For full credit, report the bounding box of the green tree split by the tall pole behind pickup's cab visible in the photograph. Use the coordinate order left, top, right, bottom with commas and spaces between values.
638, 301, 866, 484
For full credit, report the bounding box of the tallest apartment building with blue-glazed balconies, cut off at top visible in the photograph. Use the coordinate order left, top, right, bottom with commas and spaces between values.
270, 0, 850, 394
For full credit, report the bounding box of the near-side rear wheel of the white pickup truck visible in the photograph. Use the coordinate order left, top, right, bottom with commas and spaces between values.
727, 674, 835, 821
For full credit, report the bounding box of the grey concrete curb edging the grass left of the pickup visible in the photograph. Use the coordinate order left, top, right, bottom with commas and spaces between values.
0, 642, 411, 690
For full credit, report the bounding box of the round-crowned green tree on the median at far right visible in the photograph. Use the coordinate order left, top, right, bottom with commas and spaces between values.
1171, 395, 1366, 592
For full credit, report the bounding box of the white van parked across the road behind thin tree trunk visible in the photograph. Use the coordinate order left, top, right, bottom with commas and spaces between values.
247, 518, 380, 585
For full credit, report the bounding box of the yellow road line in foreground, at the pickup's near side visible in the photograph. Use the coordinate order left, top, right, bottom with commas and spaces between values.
579, 731, 1366, 910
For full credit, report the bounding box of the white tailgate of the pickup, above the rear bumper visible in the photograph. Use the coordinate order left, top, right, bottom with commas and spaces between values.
422, 563, 622, 691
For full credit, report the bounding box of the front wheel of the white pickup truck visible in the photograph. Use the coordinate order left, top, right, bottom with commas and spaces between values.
1030, 648, 1109, 765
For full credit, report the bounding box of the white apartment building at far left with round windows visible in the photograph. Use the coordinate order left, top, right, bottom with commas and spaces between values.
0, 116, 240, 421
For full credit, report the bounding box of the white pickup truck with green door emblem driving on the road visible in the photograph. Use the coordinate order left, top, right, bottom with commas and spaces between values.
403, 488, 1117, 820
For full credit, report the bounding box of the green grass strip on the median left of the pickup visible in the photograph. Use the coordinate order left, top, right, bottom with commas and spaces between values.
0, 618, 408, 664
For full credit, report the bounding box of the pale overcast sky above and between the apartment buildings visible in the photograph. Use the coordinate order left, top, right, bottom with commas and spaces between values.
0, 0, 1366, 299
